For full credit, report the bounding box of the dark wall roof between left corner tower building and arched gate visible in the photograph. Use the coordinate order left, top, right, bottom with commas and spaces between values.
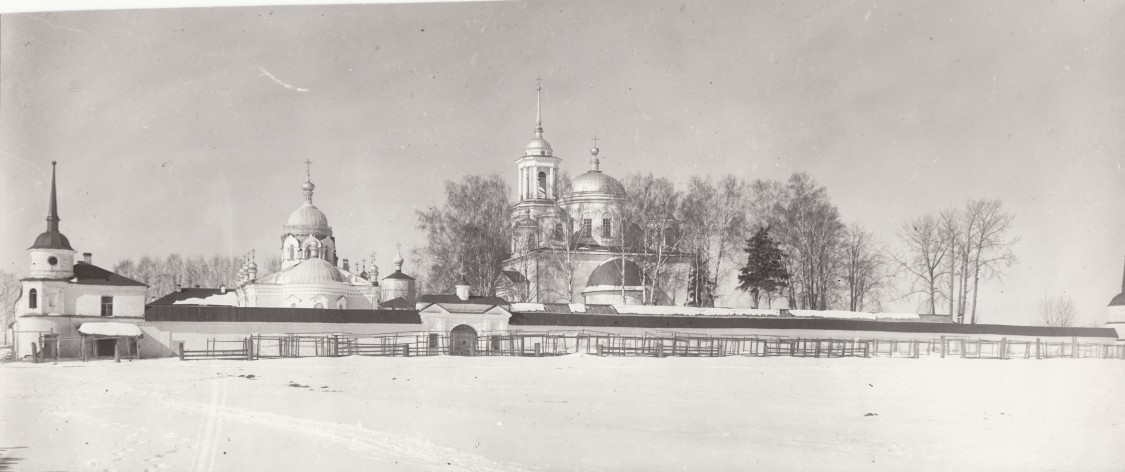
144, 305, 422, 325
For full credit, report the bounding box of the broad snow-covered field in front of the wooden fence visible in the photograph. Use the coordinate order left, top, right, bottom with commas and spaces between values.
0, 355, 1125, 471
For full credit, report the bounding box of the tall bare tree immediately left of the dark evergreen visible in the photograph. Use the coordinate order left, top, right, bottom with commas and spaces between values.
681, 175, 749, 305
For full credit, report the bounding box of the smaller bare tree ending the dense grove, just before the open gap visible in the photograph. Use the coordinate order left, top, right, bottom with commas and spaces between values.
842, 224, 888, 311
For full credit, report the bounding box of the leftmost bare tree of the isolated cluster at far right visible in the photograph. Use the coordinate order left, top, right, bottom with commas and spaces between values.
896, 215, 954, 314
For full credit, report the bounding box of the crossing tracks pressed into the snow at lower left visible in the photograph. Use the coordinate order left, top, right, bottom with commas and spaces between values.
29, 369, 531, 472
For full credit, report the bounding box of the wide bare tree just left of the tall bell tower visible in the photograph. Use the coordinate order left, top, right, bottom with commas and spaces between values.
416, 174, 512, 296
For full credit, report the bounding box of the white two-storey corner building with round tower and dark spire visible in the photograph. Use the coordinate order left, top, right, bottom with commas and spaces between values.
12, 162, 147, 357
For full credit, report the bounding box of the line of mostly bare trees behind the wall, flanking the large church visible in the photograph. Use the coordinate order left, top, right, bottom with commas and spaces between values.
417, 172, 1019, 323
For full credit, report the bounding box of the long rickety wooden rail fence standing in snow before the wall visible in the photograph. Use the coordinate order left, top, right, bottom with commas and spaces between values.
168, 330, 1125, 360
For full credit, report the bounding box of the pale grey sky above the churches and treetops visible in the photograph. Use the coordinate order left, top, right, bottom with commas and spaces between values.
0, 0, 1125, 323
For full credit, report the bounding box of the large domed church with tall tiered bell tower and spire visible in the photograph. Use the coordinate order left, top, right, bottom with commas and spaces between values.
497, 85, 690, 306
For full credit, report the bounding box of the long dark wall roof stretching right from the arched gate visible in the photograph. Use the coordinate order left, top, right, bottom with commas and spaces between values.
509, 312, 1117, 339
